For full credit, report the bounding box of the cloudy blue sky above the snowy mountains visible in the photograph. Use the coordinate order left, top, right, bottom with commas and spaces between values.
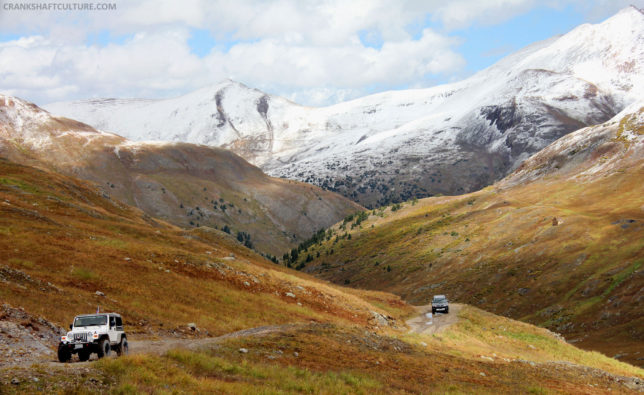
0, 0, 644, 105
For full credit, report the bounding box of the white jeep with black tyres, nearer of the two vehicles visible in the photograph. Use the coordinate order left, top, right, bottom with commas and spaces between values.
58, 313, 128, 362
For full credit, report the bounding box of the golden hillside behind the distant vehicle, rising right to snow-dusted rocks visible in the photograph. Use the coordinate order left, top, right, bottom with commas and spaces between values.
300, 108, 644, 365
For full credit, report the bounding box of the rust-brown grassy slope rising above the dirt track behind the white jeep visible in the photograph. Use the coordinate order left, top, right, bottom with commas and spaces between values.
0, 160, 408, 335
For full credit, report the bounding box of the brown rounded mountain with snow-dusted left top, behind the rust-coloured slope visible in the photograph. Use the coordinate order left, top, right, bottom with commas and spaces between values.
0, 95, 360, 255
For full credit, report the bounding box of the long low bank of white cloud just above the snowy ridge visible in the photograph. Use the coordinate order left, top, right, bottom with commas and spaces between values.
0, 24, 464, 104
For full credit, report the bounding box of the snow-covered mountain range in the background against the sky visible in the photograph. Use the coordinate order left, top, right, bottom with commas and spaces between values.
46, 7, 644, 207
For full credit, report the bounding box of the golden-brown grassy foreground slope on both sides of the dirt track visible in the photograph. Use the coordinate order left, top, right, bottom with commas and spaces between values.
0, 160, 644, 394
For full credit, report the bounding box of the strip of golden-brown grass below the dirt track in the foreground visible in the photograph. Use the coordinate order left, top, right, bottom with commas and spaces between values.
5, 306, 644, 394
